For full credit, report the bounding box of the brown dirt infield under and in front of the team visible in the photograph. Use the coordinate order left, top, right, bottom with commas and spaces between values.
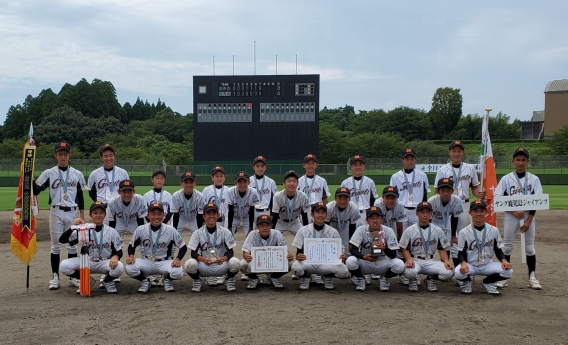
0, 211, 568, 344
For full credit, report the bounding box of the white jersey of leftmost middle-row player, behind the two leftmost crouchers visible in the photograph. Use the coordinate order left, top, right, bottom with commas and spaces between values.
107, 194, 148, 236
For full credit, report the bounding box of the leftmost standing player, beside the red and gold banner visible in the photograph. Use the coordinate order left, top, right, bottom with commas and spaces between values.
33, 142, 87, 290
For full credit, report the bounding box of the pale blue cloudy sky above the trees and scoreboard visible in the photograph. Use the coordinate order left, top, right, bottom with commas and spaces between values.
0, 0, 568, 123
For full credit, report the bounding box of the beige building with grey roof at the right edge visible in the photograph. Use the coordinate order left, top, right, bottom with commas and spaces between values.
544, 79, 568, 137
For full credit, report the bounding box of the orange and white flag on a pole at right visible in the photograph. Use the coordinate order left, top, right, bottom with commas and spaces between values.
479, 114, 497, 226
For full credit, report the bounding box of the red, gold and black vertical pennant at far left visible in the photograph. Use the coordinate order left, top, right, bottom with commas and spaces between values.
11, 138, 38, 266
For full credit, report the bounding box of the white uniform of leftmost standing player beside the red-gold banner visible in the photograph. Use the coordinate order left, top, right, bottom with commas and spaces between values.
34, 166, 87, 254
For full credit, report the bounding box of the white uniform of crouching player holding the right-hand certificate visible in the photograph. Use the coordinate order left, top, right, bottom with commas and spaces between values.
292, 223, 349, 278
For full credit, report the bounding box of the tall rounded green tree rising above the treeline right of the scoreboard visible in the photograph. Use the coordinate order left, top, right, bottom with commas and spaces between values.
430, 87, 463, 138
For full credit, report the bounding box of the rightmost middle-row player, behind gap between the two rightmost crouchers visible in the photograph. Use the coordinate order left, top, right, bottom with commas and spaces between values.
428, 177, 464, 266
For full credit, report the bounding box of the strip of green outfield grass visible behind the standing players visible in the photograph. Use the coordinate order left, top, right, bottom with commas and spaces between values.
0, 185, 568, 211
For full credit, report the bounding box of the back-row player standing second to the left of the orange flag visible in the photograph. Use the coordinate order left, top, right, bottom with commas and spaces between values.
389, 148, 430, 229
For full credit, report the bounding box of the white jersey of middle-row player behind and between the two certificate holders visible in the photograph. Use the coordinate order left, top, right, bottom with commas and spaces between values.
272, 190, 310, 235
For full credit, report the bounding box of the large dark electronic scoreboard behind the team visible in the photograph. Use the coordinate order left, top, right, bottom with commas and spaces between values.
193, 74, 319, 164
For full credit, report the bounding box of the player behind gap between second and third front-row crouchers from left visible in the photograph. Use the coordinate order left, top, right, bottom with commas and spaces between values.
172, 171, 205, 234
